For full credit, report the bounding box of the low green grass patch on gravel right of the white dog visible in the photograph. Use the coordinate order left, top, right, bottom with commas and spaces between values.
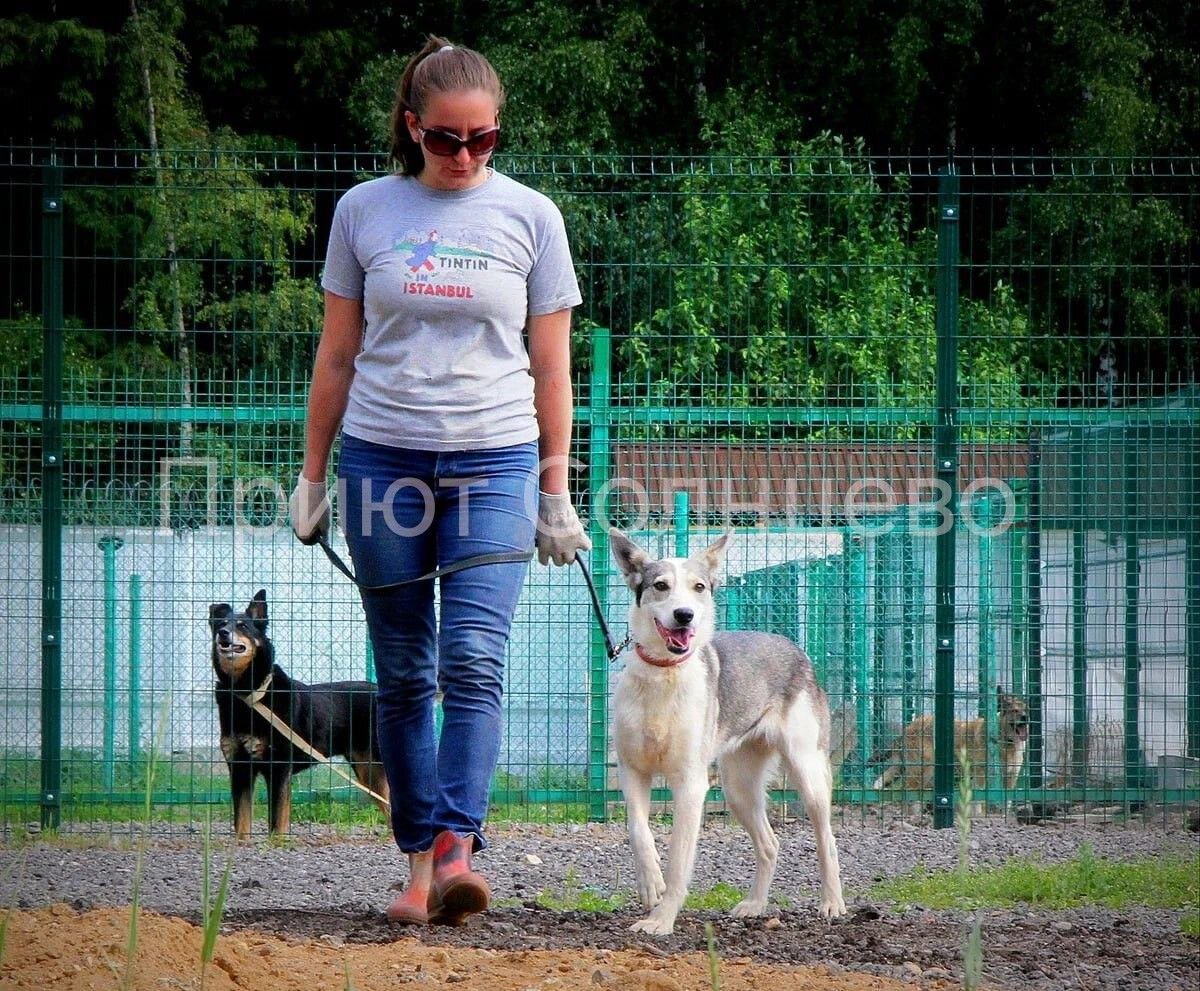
871, 845, 1200, 909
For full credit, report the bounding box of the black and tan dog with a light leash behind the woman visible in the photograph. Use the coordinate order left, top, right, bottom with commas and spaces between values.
209, 589, 390, 840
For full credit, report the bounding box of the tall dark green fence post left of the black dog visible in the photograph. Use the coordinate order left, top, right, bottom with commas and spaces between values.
41, 152, 62, 829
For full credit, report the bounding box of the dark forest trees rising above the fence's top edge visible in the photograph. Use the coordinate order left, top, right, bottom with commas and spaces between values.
0, 0, 1200, 154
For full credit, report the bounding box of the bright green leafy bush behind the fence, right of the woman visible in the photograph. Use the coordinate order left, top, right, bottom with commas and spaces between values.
618, 123, 1028, 417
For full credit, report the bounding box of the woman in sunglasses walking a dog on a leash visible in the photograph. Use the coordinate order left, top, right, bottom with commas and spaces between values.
290, 37, 590, 924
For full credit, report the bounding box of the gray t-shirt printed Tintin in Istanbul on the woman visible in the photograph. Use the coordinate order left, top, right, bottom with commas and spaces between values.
320, 172, 582, 451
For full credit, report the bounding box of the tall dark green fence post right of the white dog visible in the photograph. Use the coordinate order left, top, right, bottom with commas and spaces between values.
934, 164, 959, 829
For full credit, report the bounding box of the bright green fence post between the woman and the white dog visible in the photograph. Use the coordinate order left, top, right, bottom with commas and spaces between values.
587, 328, 612, 822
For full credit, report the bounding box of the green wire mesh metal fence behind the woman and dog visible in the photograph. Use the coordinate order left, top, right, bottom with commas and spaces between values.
0, 143, 1200, 830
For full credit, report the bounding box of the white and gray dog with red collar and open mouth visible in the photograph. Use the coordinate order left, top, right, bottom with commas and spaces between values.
610, 529, 846, 936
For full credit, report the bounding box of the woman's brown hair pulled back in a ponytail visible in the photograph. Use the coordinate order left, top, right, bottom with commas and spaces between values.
388, 35, 504, 175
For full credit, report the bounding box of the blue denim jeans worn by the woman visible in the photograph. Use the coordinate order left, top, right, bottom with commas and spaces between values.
337, 434, 538, 853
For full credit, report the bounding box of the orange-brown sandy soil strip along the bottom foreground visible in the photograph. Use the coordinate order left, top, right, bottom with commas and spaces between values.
0, 905, 936, 991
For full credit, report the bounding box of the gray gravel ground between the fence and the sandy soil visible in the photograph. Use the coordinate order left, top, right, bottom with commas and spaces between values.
0, 819, 1200, 991
